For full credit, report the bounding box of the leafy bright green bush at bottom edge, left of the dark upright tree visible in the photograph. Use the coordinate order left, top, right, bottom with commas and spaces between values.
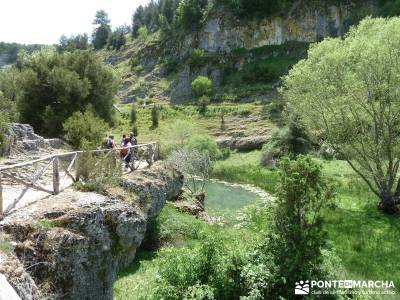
155, 234, 242, 300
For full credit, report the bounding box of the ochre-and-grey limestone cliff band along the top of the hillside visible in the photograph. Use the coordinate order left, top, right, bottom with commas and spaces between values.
198, 1, 375, 52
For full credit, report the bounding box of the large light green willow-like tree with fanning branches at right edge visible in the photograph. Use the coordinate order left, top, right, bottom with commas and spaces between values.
283, 18, 400, 212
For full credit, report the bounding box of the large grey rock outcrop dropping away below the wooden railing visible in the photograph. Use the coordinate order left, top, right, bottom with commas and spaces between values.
0, 164, 183, 299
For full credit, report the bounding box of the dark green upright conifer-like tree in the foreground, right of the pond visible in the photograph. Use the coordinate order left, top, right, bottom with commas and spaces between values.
264, 156, 334, 299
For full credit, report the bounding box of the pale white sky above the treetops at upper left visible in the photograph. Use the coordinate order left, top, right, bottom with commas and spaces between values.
0, 0, 149, 44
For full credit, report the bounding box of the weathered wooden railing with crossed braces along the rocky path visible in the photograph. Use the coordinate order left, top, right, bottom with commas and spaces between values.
0, 142, 159, 214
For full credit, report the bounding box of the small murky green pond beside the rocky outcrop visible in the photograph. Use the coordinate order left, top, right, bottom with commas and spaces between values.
197, 182, 259, 214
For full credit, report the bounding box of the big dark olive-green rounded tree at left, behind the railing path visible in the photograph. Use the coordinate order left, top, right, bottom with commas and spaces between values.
17, 48, 118, 135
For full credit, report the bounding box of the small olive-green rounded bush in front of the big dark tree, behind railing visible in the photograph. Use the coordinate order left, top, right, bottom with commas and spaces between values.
63, 107, 108, 149
